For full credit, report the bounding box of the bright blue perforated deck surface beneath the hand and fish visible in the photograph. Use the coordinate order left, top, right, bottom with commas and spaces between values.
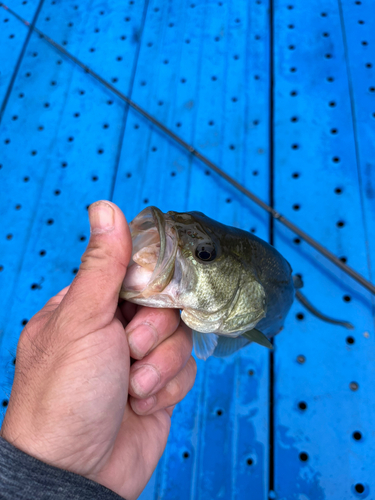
0, 0, 375, 500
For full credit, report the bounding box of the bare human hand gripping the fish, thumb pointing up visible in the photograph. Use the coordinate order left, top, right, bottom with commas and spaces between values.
1, 202, 196, 500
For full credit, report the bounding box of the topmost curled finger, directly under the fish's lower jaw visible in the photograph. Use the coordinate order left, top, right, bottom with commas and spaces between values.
125, 307, 180, 359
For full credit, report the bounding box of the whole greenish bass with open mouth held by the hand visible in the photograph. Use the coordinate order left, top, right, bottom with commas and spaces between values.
120, 206, 295, 359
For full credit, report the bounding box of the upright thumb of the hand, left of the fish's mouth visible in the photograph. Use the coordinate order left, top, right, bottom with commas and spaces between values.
59, 201, 132, 330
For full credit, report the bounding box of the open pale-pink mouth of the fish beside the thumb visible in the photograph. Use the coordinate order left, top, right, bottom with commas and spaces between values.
120, 207, 178, 300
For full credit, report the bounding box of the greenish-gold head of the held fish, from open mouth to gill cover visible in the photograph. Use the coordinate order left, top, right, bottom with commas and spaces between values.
120, 207, 266, 336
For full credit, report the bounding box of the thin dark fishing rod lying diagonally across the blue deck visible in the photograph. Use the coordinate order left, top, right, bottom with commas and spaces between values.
0, 2, 375, 295
